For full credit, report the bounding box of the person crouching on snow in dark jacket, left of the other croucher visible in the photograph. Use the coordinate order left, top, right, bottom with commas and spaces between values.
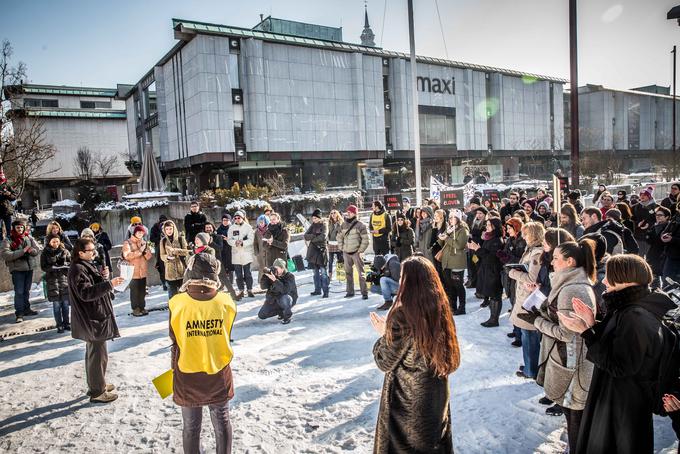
257, 259, 297, 325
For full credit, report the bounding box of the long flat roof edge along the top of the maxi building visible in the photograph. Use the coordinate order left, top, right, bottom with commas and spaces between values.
171, 19, 567, 83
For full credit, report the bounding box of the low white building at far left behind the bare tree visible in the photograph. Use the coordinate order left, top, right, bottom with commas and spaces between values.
5, 84, 131, 207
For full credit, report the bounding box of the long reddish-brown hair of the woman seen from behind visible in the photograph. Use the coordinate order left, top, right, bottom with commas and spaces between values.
385, 256, 460, 377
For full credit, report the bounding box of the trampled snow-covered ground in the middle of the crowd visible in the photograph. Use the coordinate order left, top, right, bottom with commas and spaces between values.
0, 272, 677, 454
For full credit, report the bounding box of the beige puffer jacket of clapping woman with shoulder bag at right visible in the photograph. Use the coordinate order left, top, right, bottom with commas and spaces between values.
534, 268, 597, 410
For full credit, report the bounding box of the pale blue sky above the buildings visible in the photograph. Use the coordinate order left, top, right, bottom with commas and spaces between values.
5, 0, 680, 88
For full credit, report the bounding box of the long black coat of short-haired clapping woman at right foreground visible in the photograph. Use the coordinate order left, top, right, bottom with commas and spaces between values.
575, 286, 675, 454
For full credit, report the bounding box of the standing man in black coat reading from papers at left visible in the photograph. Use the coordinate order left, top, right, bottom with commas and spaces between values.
68, 238, 123, 403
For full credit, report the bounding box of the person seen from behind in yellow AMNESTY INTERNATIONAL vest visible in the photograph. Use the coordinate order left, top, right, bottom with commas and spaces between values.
169, 253, 236, 454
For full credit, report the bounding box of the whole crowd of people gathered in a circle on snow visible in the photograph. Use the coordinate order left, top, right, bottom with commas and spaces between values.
0, 183, 680, 453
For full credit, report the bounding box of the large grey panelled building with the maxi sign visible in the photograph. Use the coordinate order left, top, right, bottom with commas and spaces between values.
118, 17, 568, 193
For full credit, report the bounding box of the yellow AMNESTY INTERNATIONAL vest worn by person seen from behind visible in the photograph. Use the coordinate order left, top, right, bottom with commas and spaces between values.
168, 292, 236, 374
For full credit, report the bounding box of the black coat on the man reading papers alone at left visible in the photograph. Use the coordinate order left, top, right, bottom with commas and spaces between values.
68, 260, 120, 342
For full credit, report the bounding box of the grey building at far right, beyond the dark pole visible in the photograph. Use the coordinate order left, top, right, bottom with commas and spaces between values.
564, 85, 680, 172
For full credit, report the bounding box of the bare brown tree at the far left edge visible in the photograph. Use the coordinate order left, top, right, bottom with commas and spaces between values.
0, 40, 56, 195
